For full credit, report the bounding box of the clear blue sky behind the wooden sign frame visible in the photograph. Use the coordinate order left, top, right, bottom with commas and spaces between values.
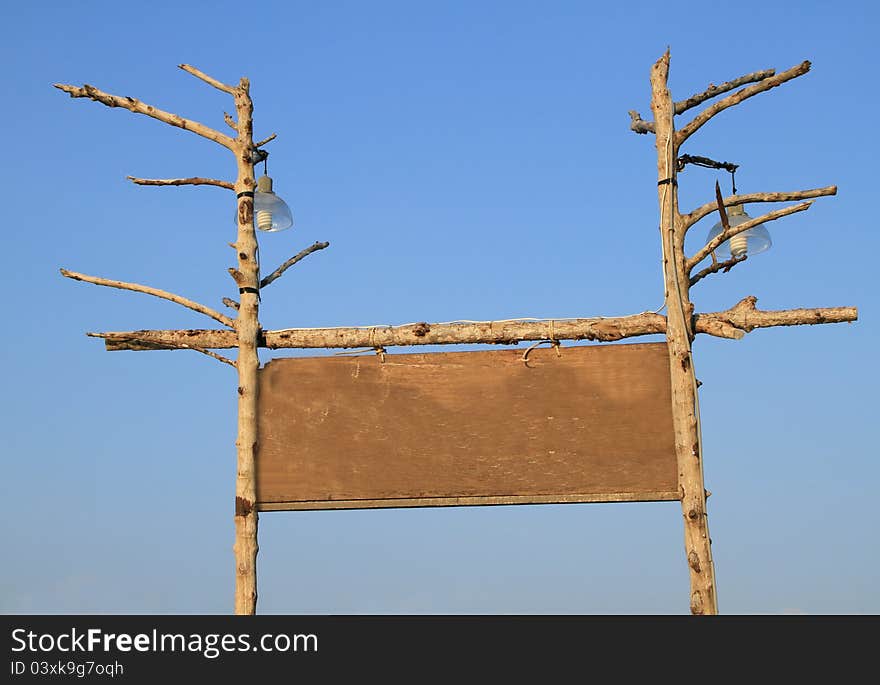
0, 0, 880, 614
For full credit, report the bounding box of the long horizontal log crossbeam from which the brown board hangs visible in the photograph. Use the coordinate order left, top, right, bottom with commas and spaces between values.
88, 296, 858, 351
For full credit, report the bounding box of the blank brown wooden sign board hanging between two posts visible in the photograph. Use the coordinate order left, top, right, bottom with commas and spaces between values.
257, 343, 679, 511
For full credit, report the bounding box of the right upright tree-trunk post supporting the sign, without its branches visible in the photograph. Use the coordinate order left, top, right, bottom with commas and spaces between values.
651, 51, 718, 614
